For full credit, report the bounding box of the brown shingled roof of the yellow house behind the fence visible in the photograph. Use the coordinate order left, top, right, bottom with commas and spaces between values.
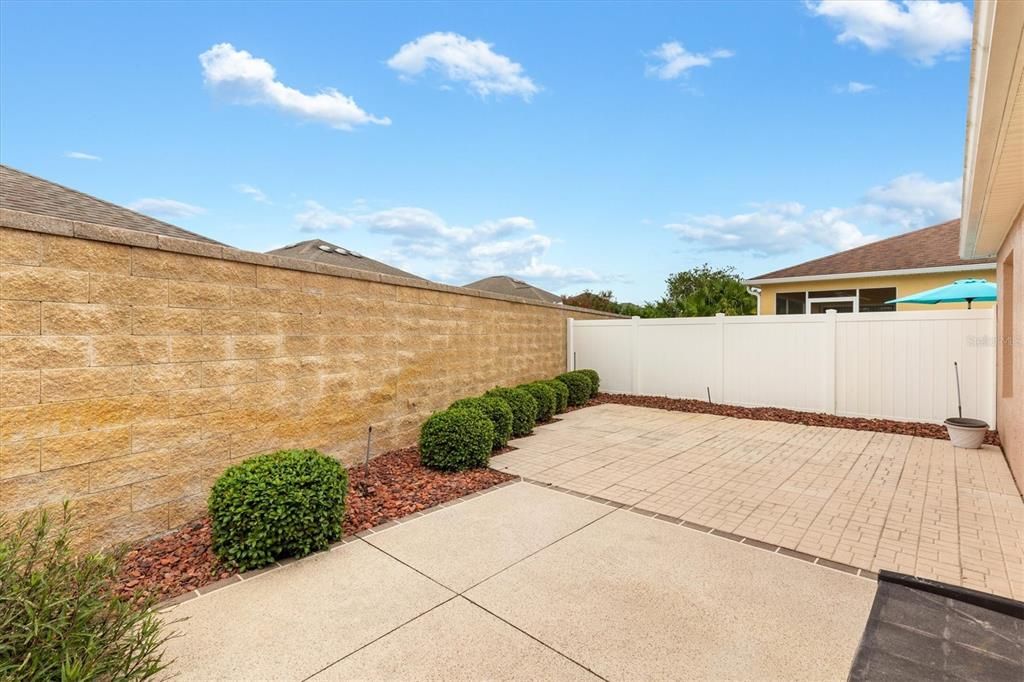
749, 218, 995, 282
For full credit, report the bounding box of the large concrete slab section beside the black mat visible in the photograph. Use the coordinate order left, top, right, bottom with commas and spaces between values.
465, 511, 876, 680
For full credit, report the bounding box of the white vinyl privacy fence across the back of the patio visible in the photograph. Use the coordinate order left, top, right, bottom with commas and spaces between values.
567, 309, 995, 426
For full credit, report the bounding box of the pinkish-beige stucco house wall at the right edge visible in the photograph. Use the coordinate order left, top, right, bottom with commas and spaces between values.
995, 212, 1024, 493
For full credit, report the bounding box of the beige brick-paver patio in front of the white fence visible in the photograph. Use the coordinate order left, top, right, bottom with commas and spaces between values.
492, 404, 1024, 599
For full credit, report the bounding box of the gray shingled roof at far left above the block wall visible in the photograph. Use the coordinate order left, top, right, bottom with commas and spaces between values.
0, 164, 220, 244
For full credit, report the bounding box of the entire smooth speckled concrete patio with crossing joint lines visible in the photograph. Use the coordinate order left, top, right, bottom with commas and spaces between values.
165, 482, 876, 680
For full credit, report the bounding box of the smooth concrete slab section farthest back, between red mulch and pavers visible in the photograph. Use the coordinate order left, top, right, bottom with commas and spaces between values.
365, 483, 612, 592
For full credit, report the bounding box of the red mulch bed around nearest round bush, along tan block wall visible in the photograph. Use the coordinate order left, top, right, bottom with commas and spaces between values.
115, 447, 514, 601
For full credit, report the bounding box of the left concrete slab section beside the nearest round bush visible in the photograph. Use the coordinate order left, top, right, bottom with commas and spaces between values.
164, 542, 454, 680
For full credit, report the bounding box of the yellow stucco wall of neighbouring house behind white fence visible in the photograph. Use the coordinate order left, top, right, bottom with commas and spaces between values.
759, 269, 995, 315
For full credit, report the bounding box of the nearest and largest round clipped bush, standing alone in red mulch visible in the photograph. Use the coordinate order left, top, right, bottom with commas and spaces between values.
208, 450, 348, 570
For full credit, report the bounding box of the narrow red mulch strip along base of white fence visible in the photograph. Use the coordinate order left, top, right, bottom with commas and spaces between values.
589, 393, 999, 445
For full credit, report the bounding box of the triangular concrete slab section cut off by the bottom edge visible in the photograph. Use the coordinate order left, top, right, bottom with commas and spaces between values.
312, 597, 599, 682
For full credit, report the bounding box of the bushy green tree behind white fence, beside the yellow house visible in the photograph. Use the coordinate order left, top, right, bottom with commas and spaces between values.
657, 263, 758, 317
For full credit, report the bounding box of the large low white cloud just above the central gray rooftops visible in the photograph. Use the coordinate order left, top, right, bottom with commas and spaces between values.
352, 207, 606, 288
